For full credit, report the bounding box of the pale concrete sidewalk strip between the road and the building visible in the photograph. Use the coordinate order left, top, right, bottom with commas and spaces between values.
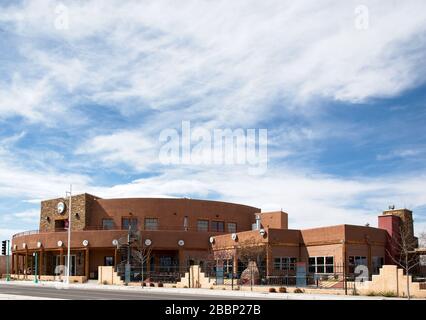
0, 280, 404, 300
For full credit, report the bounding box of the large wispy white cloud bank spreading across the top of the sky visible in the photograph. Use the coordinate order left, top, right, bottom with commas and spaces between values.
0, 0, 426, 123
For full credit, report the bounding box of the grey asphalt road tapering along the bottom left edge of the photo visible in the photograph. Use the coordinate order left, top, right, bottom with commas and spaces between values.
0, 284, 259, 300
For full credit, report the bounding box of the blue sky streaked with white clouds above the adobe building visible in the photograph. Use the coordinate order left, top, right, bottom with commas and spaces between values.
0, 0, 426, 238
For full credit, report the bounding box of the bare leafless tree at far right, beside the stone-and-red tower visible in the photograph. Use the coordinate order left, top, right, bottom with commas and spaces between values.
386, 223, 420, 300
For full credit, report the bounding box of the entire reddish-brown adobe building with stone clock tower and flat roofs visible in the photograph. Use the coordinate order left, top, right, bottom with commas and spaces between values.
8, 194, 413, 280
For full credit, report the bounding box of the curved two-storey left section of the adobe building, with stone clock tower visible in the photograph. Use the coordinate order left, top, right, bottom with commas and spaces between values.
12, 194, 260, 279
